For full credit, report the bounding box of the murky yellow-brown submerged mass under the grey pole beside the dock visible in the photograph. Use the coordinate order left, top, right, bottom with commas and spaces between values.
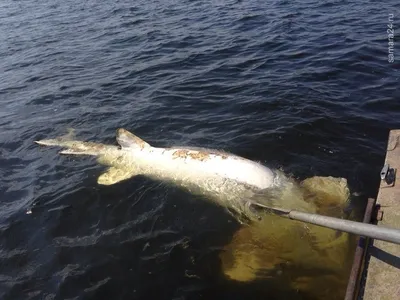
220, 177, 356, 300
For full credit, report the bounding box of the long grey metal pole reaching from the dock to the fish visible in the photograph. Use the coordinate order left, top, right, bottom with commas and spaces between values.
251, 202, 400, 244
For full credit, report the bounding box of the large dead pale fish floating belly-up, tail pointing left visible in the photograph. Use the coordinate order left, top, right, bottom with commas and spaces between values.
36, 128, 280, 221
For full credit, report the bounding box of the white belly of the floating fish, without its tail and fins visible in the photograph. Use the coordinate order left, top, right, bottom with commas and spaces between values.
114, 147, 276, 221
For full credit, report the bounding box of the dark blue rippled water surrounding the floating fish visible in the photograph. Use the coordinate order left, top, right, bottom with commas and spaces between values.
0, 0, 400, 299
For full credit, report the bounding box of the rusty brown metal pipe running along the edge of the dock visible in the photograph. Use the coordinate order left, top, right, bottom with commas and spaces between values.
344, 198, 376, 300
